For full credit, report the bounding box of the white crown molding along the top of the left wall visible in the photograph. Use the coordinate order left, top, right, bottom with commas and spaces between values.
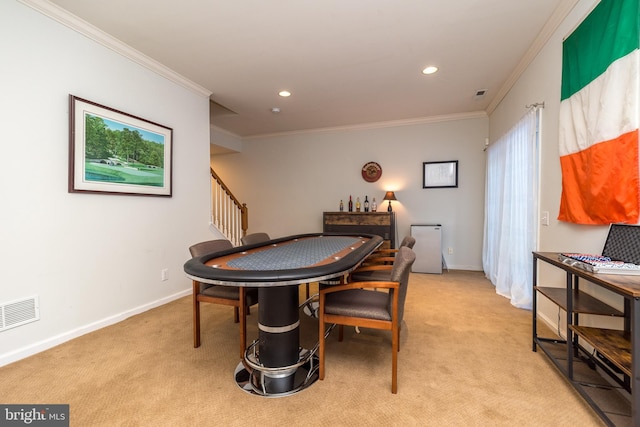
18, 0, 212, 98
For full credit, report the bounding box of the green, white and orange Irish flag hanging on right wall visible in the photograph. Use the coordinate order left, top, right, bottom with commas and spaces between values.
558, 0, 640, 224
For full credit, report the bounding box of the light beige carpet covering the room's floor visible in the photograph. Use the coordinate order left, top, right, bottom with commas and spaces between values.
0, 271, 604, 426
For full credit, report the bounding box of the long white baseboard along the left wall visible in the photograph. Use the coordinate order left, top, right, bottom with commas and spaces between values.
0, 287, 191, 366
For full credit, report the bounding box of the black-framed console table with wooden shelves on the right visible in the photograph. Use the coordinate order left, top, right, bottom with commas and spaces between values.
532, 252, 640, 426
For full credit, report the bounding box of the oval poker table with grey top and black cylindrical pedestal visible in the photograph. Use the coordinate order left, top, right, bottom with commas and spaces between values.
184, 233, 382, 397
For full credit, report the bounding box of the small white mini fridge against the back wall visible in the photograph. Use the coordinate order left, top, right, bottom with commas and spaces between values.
411, 224, 442, 274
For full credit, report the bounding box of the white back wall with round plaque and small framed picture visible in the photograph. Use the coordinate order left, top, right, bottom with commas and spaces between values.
211, 114, 488, 270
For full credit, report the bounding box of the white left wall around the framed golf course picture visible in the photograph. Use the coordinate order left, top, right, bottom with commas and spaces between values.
0, 1, 218, 365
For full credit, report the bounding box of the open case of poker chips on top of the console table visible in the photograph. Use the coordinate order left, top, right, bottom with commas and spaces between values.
558, 224, 640, 275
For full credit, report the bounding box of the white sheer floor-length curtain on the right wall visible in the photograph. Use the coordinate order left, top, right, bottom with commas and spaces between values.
482, 108, 540, 309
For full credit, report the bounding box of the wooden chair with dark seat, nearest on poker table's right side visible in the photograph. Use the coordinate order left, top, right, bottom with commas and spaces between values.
318, 246, 416, 394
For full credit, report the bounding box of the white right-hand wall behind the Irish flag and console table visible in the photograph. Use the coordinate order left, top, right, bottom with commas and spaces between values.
489, 0, 622, 325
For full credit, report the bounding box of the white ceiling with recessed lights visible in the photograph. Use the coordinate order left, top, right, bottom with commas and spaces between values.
45, 0, 577, 137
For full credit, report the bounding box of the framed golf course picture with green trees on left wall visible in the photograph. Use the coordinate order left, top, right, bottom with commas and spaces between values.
69, 95, 173, 197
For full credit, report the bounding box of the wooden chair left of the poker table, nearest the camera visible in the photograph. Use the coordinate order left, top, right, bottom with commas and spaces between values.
189, 239, 258, 358
